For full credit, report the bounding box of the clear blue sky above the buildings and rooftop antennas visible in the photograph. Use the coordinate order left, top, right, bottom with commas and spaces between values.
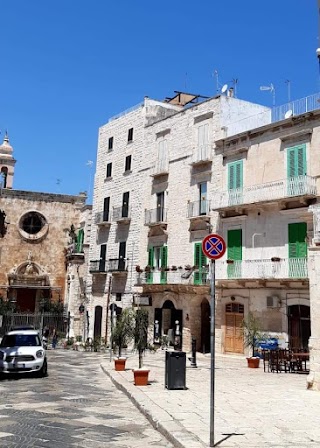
0, 0, 320, 202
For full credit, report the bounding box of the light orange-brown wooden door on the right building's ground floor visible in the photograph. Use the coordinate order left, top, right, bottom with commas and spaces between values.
224, 303, 244, 353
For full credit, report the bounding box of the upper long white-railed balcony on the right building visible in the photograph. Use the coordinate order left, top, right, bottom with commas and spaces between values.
211, 176, 317, 211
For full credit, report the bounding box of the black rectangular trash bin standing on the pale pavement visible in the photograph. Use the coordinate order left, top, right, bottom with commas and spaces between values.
165, 351, 186, 390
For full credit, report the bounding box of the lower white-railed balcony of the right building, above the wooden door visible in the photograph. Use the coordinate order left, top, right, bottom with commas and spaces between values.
216, 258, 308, 280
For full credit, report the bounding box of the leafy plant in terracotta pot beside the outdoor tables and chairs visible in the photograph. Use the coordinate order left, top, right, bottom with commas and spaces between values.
241, 312, 264, 368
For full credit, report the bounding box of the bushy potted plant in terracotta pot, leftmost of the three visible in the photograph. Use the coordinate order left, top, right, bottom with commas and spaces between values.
111, 308, 134, 371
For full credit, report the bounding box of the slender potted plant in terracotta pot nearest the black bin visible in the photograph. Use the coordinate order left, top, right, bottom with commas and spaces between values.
133, 308, 149, 386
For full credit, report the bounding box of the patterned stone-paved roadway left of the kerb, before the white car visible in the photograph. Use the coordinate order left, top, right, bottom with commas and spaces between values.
0, 350, 172, 448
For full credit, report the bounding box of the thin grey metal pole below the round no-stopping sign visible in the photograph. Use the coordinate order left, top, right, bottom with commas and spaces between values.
210, 260, 216, 446
